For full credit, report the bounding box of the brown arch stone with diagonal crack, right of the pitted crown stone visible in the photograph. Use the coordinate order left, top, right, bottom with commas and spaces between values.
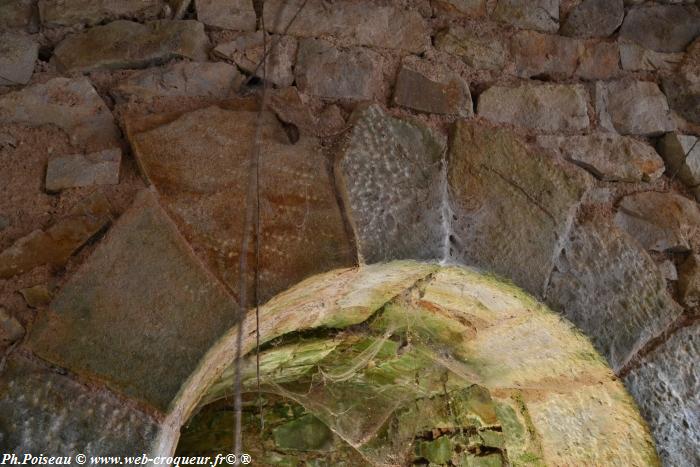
448, 121, 590, 294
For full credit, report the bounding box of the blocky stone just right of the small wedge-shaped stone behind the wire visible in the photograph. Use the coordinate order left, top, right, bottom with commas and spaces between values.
294, 39, 383, 100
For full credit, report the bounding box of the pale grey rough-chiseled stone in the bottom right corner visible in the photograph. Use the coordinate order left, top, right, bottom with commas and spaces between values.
625, 322, 700, 466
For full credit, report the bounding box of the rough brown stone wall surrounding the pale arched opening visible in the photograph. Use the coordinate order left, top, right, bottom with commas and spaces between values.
0, 0, 700, 465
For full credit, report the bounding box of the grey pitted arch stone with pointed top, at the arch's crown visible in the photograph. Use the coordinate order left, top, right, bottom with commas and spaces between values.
335, 105, 448, 264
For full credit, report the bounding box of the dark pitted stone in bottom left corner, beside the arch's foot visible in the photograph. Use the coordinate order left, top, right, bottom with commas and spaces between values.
0, 352, 159, 454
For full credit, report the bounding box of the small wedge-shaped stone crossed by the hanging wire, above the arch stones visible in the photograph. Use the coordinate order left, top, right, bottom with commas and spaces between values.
214, 31, 297, 86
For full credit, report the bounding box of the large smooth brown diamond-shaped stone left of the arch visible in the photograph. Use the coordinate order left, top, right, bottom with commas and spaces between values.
28, 191, 238, 412
